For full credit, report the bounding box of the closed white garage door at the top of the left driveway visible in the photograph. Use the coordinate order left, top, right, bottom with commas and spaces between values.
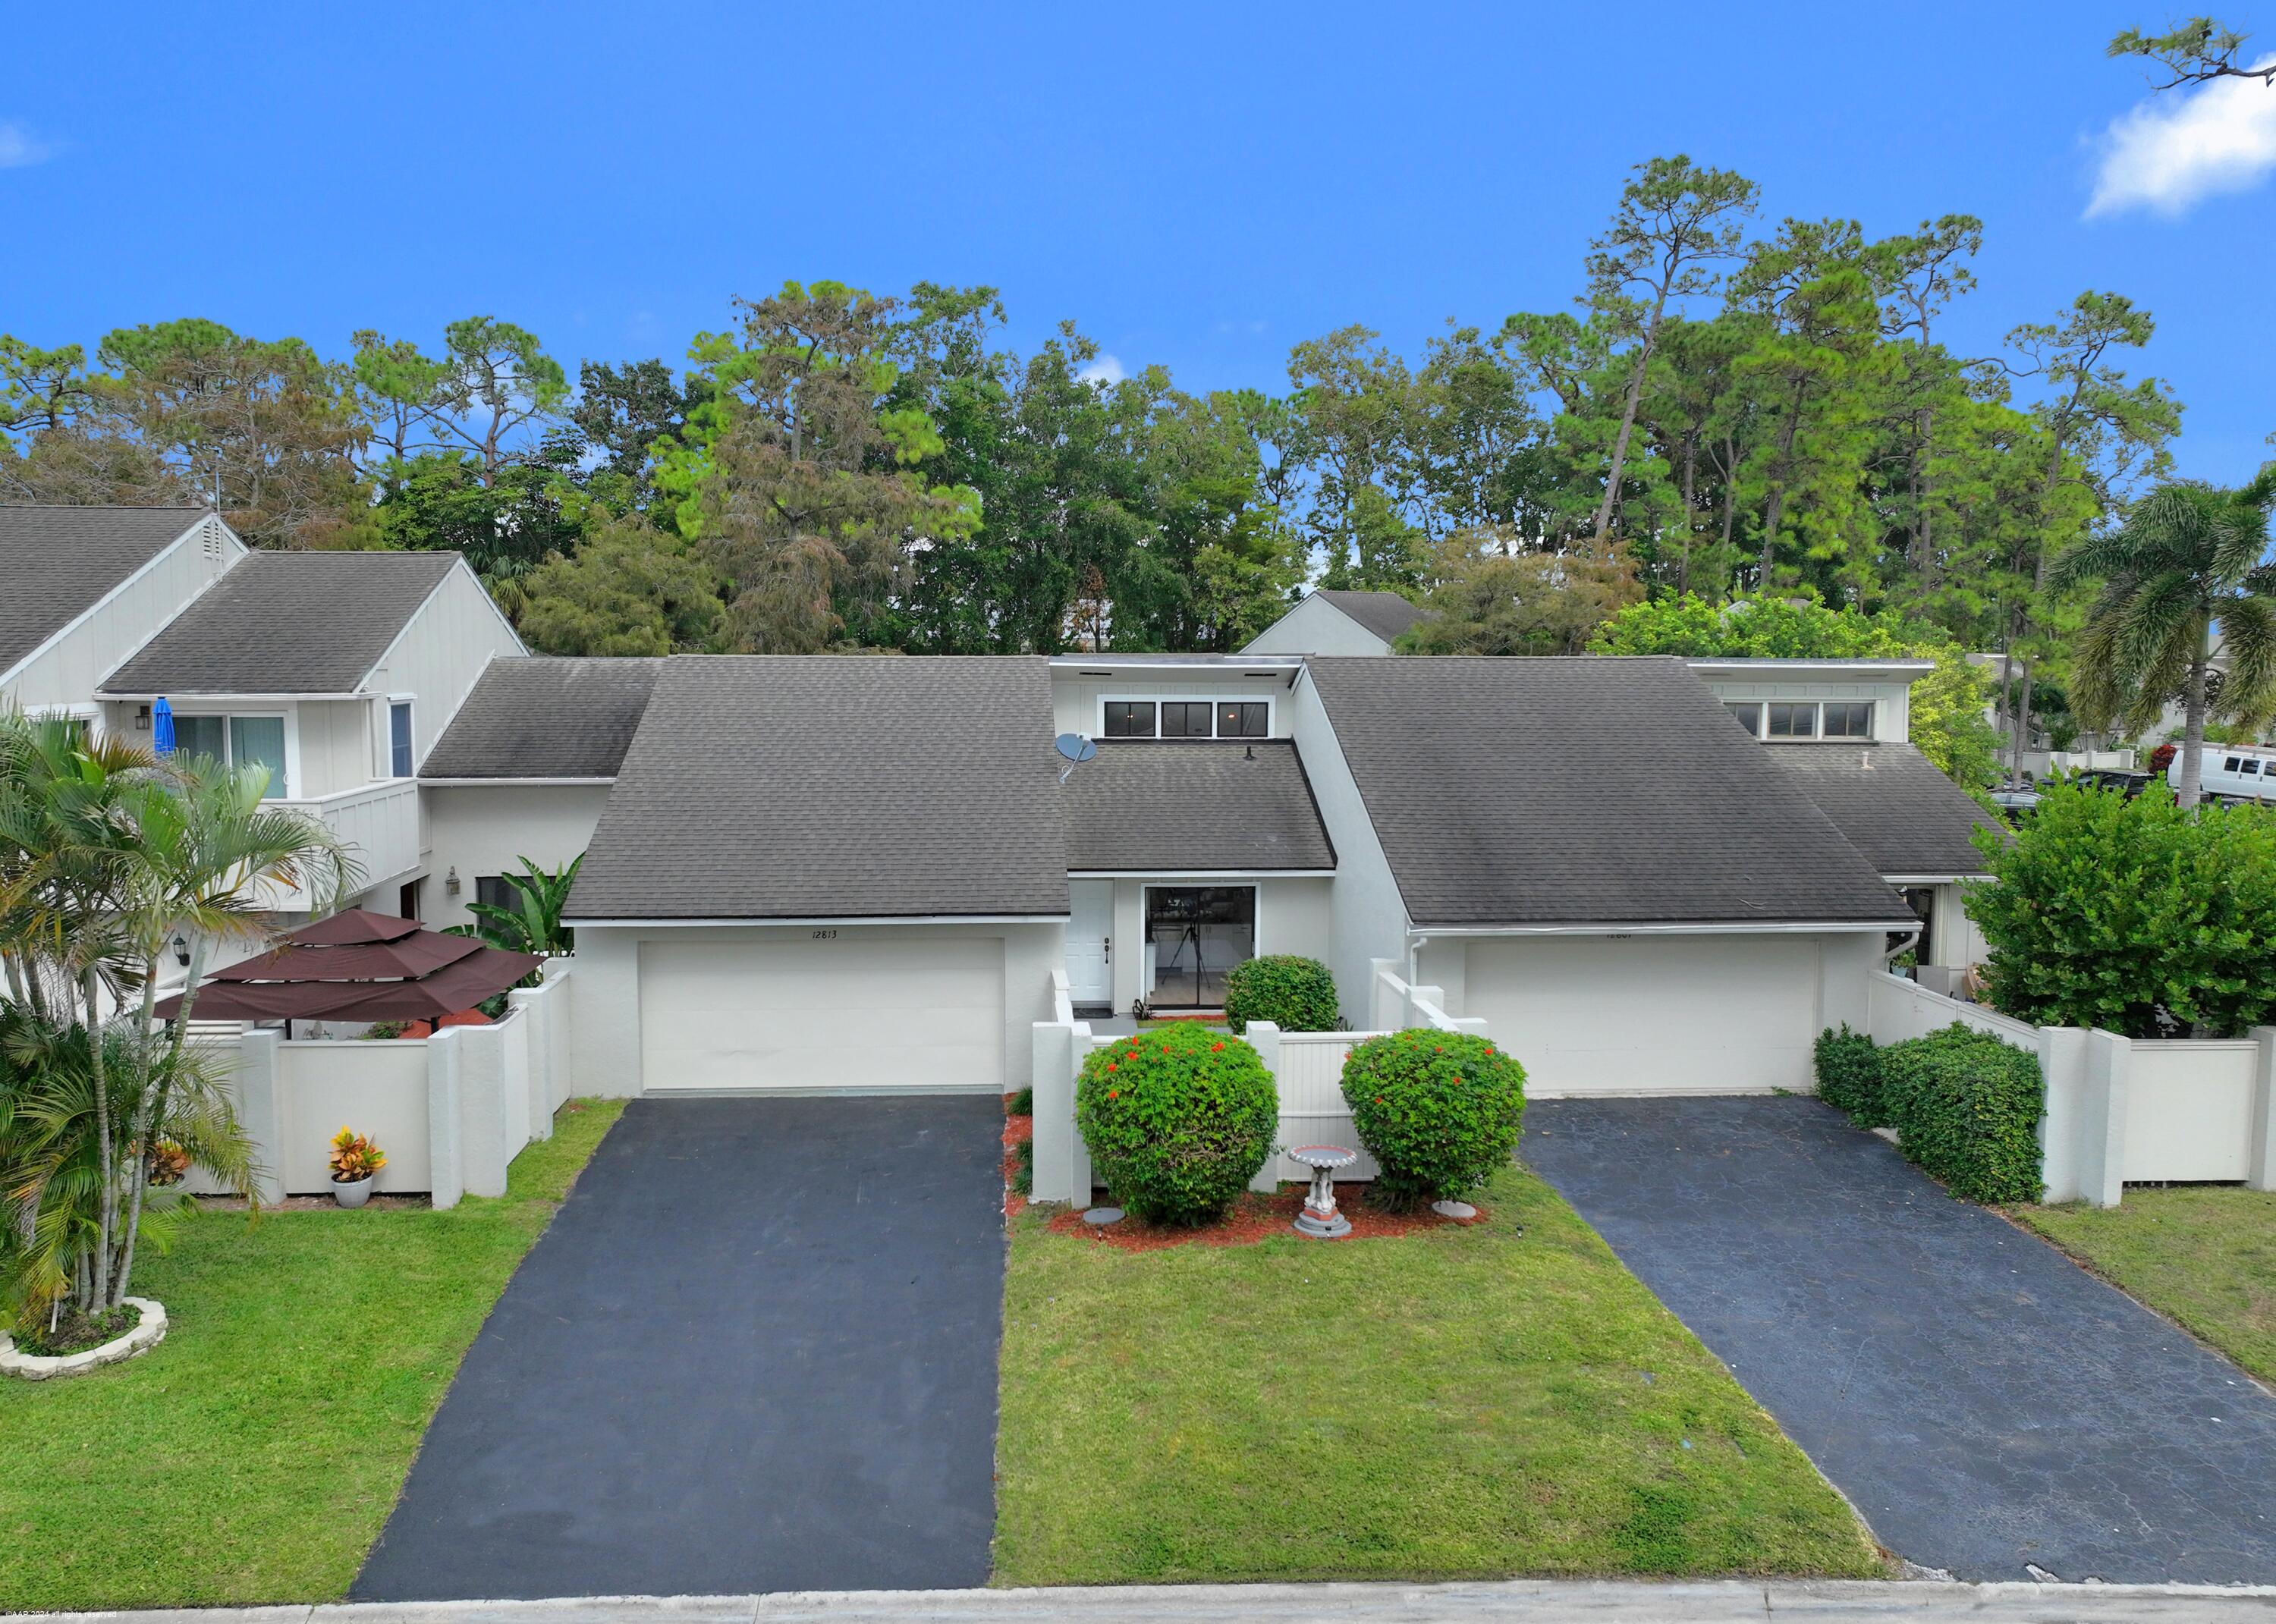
640, 935, 1004, 1094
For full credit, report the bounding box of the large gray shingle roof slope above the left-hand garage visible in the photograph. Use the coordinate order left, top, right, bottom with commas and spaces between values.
569, 655, 1067, 919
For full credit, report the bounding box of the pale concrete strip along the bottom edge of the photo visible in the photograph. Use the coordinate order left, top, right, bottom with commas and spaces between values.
9, 1578, 2276, 1624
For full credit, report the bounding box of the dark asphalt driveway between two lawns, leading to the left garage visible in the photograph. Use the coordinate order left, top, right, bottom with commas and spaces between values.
351, 1096, 1004, 1601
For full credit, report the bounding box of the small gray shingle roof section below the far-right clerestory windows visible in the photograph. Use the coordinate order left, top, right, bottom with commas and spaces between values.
1762, 744, 2001, 875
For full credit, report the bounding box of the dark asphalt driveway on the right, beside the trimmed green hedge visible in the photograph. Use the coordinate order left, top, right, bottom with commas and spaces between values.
1523, 1098, 2276, 1583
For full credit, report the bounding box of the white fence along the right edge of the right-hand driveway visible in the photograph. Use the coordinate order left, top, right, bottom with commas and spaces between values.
1866, 971, 2276, 1208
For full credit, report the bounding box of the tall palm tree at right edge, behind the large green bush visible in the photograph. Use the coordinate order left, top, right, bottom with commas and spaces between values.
2053, 462, 2276, 808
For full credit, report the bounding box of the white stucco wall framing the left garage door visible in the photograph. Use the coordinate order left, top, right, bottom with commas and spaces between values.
569, 921, 1067, 1096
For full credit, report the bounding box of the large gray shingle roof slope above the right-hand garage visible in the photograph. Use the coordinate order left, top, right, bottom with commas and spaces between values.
1311, 655, 1907, 925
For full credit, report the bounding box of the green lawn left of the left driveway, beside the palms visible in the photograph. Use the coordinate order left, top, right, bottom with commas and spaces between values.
0, 1101, 621, 1610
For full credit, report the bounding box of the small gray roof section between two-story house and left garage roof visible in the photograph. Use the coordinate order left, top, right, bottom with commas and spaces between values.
419, 658, 665, 778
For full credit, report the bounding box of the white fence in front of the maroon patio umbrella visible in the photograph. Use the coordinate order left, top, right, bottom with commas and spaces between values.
191, 957, 574, 1208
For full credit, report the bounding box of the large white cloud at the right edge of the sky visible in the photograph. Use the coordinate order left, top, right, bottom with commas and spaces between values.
2087, 57, 2276, 218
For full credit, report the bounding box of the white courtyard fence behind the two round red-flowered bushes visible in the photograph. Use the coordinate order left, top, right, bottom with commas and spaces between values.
1033, 960, 1486, 1205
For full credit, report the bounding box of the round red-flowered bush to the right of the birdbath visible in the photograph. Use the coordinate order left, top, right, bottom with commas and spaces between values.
1343, 1028, 1525, 1210
